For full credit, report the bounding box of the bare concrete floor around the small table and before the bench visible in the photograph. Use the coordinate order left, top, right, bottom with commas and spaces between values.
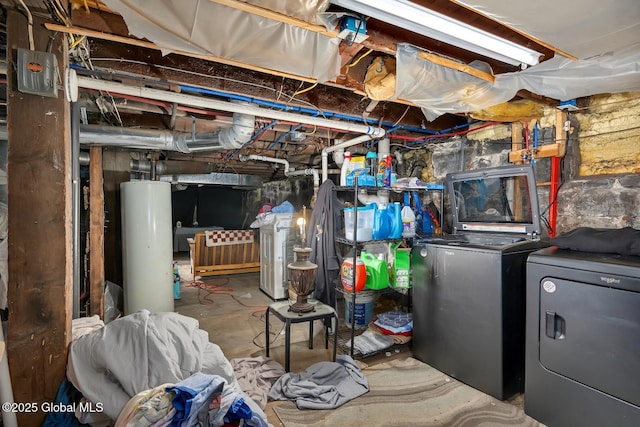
174, 252, 523, 427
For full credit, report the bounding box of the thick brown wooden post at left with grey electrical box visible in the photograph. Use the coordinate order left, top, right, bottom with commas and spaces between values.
7, 9, 73, 426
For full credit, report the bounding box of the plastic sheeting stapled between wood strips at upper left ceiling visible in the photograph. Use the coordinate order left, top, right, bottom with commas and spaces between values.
104, 0, 340, 82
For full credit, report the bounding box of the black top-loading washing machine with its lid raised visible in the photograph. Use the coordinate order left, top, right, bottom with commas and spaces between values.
411, 166, 548, 400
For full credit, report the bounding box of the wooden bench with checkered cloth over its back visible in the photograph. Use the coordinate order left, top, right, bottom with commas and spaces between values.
189, 230, 260, 277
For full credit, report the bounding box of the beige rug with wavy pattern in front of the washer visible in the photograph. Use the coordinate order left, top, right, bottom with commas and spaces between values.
273, 358, 542, 427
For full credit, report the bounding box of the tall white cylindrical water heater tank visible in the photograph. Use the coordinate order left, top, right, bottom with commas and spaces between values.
120, 181, 174, 315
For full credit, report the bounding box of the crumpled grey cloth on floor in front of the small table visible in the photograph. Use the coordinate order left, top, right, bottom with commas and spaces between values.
269, 355, 369, 409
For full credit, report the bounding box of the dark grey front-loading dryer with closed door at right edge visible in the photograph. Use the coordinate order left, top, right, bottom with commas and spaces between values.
524, 247, 640, 427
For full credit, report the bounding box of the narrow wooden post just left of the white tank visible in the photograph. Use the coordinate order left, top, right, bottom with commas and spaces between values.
89, 146, 105, 320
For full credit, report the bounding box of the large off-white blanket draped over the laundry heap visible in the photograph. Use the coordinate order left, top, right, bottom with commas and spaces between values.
67, 310, 266, 420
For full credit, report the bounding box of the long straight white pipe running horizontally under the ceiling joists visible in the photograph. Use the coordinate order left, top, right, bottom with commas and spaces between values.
77, 76, 385, 139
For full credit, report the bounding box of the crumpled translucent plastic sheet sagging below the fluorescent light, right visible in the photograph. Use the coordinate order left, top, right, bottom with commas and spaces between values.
395, 43, 640, 121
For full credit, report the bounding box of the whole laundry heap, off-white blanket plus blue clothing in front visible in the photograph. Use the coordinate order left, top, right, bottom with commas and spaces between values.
58, 310, 268, 427
